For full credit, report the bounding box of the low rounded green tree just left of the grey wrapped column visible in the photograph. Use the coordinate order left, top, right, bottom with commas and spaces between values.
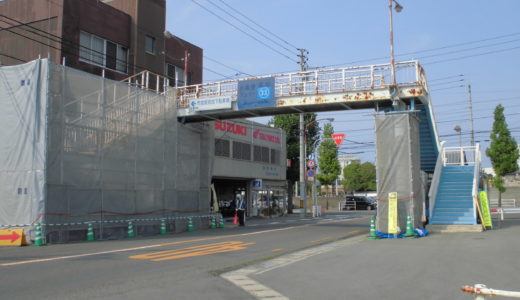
343, 161, 376, 192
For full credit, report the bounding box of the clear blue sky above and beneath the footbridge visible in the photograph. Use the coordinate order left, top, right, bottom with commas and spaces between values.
166, 0, 520, 166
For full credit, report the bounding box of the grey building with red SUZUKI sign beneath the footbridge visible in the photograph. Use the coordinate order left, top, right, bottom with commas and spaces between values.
212, 120, 287, 216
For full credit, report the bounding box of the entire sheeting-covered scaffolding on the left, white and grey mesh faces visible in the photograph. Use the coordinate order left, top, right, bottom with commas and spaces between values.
0, 60, 214, 242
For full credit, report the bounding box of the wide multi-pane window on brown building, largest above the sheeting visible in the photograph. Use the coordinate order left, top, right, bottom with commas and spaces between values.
79, 31, 128, 73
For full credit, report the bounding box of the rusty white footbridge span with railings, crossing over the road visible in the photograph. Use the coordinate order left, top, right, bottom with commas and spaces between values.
177, 61, 428, 122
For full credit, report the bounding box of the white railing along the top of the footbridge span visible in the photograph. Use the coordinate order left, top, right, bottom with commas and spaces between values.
177, 60, 428, 108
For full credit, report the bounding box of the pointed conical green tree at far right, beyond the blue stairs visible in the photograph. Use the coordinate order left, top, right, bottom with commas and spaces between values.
486, 104, 519, 207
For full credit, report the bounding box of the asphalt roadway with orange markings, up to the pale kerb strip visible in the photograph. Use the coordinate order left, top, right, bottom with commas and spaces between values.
0, 212, 373, 300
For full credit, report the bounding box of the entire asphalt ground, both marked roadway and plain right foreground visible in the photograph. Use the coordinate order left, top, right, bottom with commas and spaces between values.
0, 212, 520, 300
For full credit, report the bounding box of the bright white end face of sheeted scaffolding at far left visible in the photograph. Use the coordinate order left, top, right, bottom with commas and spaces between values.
0, 61, 48, 224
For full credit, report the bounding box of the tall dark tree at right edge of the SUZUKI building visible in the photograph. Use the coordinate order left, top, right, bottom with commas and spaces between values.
269, 113, 320, 213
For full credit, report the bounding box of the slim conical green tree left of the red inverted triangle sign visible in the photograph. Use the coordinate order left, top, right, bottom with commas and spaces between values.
316, 123, 341, 185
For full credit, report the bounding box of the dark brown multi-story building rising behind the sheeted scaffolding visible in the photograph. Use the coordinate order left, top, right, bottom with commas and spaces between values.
0, 0, 202, 86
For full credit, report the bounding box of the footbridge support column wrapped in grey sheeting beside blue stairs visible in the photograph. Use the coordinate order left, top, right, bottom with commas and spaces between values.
375, 112, 424, 233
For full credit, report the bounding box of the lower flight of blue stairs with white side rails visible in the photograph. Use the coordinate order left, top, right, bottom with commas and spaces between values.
430, 144, 480, 225
